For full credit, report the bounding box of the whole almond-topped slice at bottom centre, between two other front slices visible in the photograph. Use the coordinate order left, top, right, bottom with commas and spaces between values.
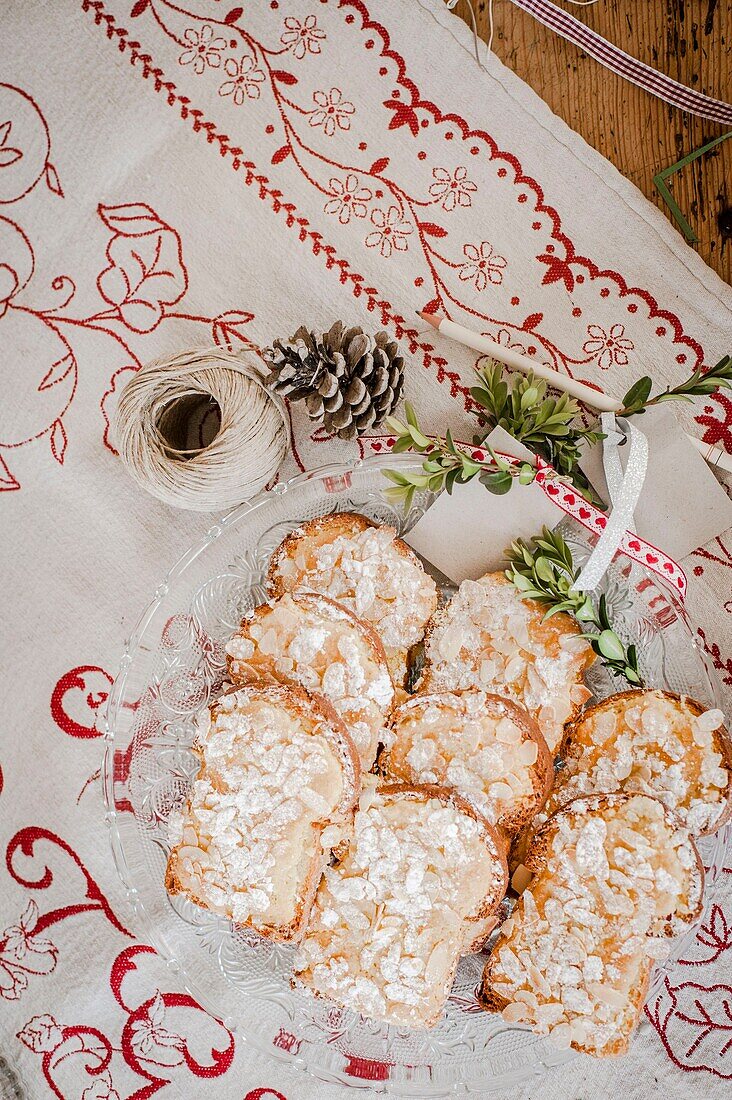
295, 783, 506, 1027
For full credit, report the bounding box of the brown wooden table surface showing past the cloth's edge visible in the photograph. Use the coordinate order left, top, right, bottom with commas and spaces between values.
456, 0, 732, 283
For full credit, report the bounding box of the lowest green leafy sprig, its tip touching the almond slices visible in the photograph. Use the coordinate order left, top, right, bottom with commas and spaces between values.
505, 527, 643, 688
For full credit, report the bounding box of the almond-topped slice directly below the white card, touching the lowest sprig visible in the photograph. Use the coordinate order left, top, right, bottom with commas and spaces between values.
418, 573, 594, 755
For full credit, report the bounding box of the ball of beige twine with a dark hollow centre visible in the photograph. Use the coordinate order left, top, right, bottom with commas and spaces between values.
114, 348, 288, 512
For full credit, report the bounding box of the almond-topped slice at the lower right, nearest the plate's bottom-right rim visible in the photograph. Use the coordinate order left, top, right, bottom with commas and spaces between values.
479, 793, 703, 1057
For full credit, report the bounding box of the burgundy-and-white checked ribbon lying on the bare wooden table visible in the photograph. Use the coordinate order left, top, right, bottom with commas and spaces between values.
513, 0, 732, 125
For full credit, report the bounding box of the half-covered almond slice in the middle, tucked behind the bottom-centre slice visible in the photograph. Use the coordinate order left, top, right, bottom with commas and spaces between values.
379, 689, 554, 835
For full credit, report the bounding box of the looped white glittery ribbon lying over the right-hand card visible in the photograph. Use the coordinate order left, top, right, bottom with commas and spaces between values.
575, 413, 648, 592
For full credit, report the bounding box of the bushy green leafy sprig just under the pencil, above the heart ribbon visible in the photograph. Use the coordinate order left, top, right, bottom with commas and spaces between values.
470, 360, 604, 504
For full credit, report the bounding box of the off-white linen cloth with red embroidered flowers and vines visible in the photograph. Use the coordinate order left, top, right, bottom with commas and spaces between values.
0, 0, 732, 1100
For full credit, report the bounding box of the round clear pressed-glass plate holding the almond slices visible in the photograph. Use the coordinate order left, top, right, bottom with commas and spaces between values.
103, 454, 730, 1097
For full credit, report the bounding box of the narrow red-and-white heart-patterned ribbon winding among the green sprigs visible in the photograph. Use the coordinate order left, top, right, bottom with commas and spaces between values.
361, 436, 687, 600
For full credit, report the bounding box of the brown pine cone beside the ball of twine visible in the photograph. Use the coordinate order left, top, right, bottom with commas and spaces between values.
262, 321, 404, 439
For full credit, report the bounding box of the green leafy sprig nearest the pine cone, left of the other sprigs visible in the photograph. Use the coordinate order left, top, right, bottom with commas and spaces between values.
384, 402, 537, 510
